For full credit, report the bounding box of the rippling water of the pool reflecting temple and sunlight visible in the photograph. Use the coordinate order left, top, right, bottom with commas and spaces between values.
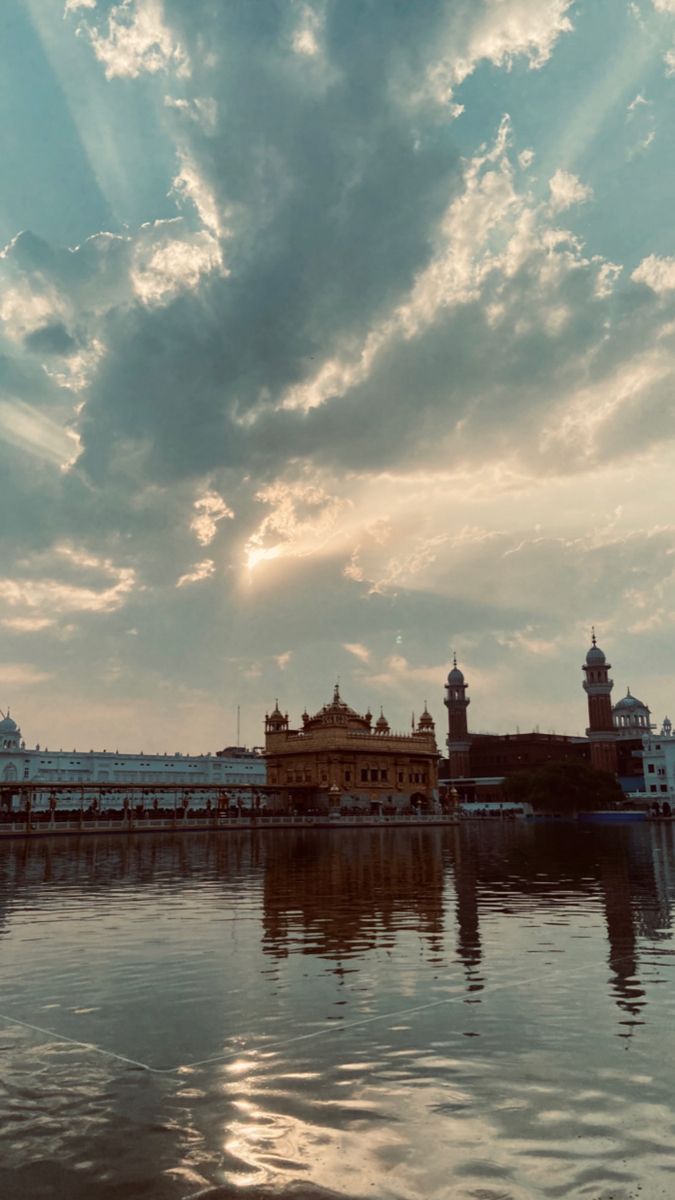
0, 823, 675, 1200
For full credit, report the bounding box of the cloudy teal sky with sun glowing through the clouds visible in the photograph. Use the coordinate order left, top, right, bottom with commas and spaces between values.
0, 0, 675, 754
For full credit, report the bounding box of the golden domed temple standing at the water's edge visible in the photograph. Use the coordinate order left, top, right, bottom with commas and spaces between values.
260, 685, 438, 812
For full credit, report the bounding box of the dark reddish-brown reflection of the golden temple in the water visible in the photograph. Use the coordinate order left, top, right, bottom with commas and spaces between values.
263, 829, 443, 961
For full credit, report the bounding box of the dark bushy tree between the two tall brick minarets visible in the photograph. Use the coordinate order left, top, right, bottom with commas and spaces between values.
503, 761, 623, 812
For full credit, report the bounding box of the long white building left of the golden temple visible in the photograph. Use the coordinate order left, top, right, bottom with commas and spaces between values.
0, 713, 267, 808
